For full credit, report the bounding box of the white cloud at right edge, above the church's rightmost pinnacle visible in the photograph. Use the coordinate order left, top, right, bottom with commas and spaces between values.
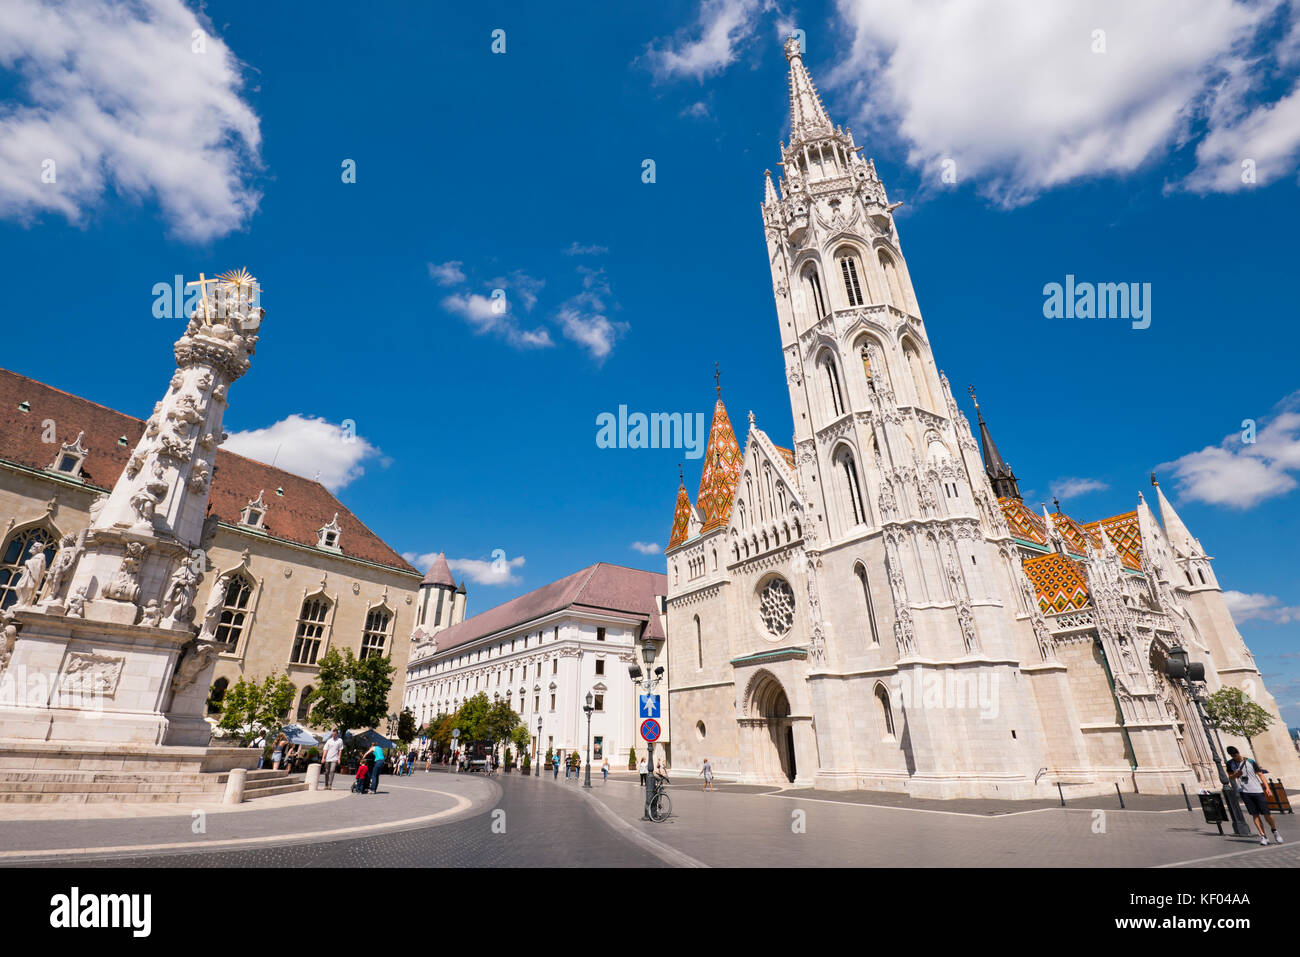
1156, 391, 1300, 508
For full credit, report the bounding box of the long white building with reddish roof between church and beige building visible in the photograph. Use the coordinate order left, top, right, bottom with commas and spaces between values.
404, 563, 668, 768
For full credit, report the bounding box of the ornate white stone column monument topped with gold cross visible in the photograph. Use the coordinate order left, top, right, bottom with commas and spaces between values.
0, 269, 264, 746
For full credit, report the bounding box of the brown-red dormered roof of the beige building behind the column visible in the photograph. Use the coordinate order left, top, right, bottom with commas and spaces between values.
0, 369, 419, 573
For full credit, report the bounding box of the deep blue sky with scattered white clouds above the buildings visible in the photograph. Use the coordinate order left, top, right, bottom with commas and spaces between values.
0, 0, 1300, 724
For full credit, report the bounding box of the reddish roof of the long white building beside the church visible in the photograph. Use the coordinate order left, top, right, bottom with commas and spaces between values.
434, 562, 668, 654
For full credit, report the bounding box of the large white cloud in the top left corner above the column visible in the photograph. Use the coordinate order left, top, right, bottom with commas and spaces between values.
0, 0, 261, 242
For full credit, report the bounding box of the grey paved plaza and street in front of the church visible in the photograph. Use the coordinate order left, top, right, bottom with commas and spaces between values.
0, 770, 1300, 867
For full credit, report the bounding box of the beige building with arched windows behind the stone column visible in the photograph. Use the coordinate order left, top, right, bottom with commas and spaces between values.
0, 369, 420, 740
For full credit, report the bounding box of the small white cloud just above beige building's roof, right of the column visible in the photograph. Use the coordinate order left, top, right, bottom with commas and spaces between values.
221, 412, 380, 494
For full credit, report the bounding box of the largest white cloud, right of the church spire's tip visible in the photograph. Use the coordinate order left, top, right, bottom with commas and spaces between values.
829, 0, 1295, 205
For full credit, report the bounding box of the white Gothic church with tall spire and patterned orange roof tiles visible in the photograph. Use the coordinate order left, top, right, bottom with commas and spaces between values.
666, 39, 1300, 798
